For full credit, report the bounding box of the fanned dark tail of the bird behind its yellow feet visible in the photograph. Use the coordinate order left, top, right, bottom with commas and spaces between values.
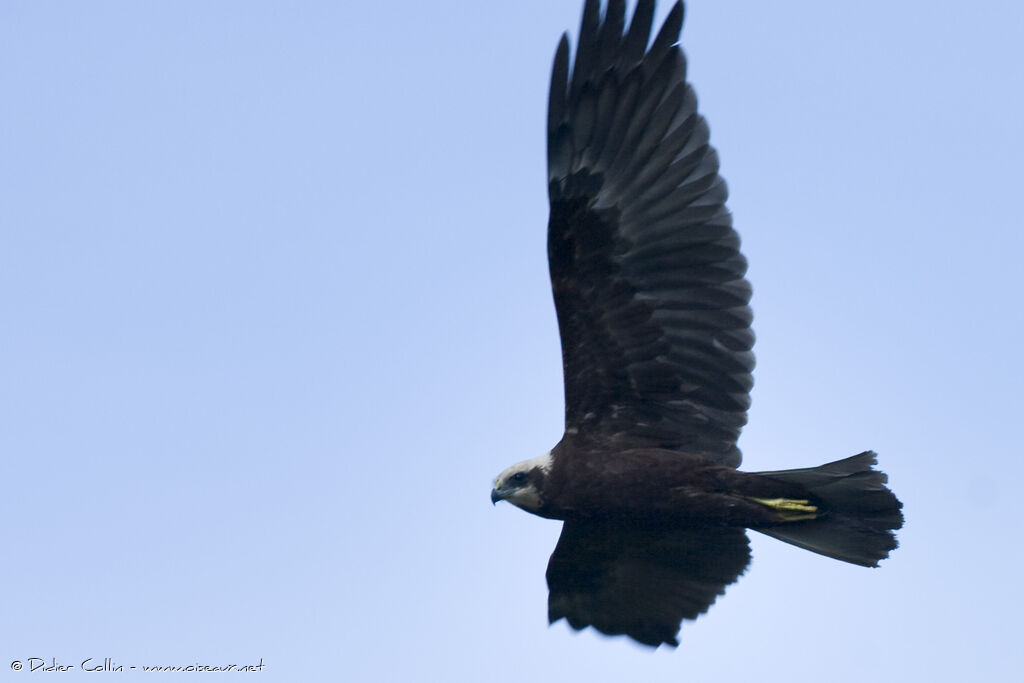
755, 451, 903, 566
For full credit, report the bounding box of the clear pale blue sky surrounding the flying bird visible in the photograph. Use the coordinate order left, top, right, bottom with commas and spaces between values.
0, 0, 1024, 683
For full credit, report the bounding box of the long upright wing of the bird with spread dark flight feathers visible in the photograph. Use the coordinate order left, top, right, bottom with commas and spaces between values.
548, 0, 754, 467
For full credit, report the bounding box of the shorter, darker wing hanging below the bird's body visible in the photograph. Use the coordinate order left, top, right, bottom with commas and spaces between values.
548, 520, 751, 647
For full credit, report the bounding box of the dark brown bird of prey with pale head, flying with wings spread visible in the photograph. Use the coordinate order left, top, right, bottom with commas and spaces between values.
490, 0, 903, 647
